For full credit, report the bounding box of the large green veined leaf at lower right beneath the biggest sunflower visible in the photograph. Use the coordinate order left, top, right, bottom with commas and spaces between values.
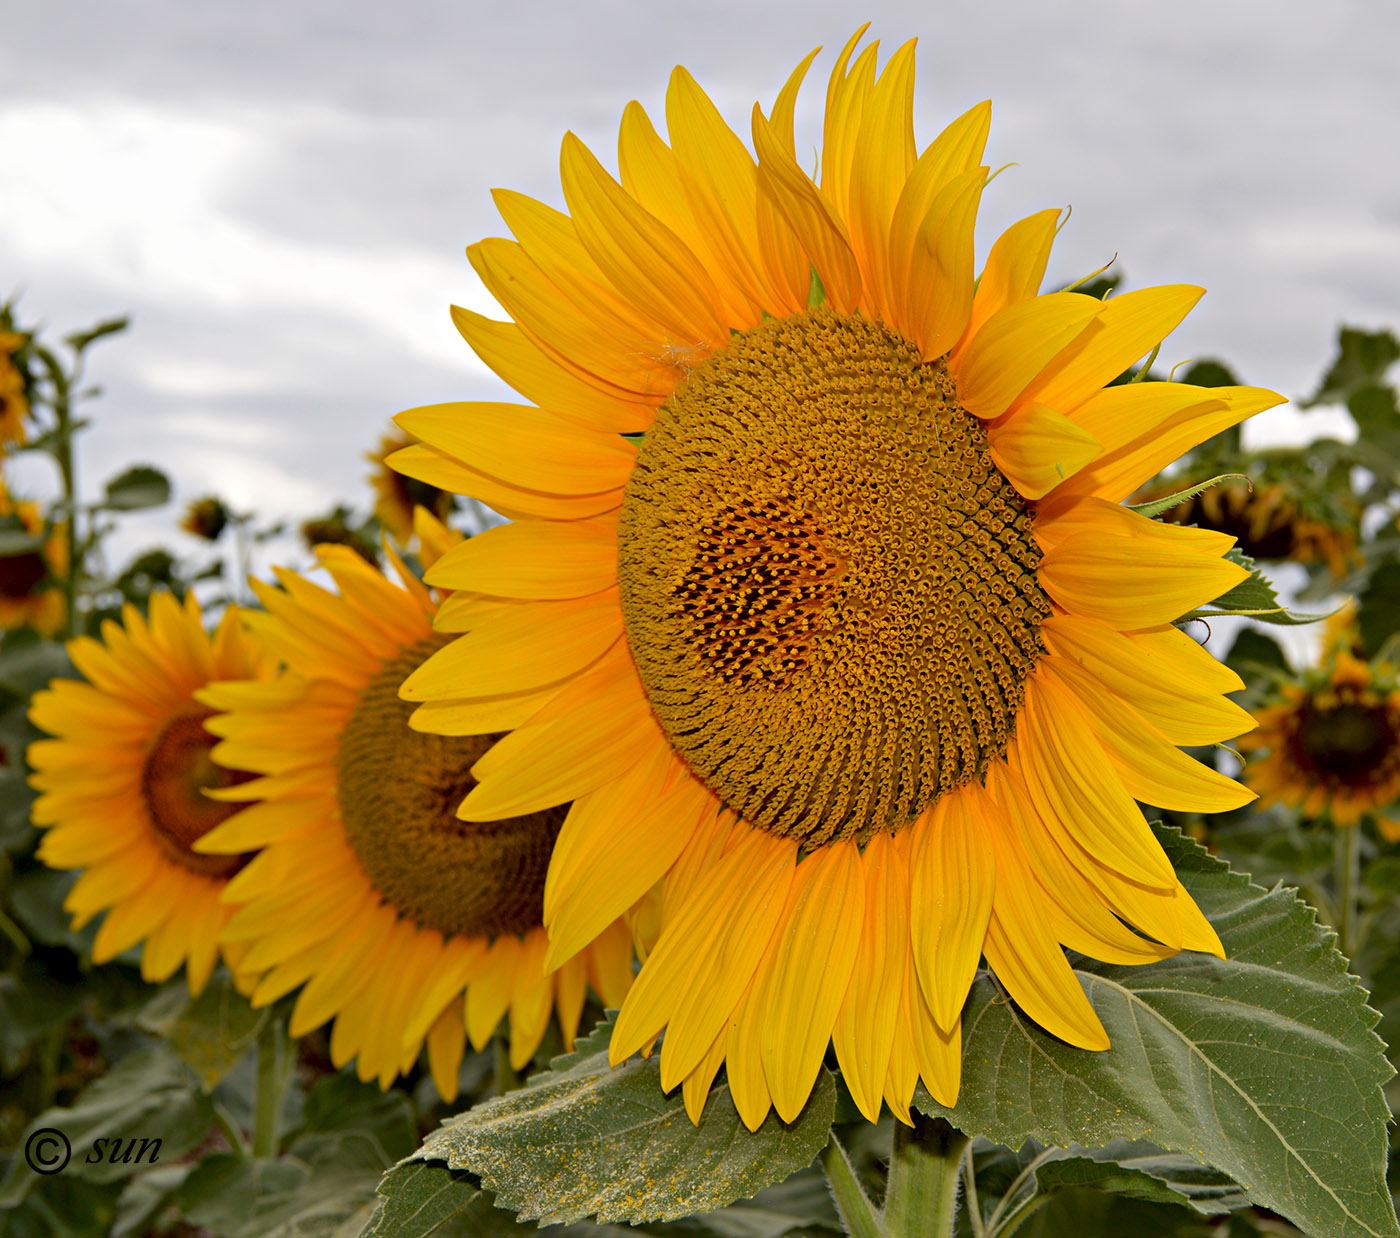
916, 826, 1400, 1238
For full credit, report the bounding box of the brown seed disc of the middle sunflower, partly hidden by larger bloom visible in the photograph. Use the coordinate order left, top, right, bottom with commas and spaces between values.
339, 637, 568, 937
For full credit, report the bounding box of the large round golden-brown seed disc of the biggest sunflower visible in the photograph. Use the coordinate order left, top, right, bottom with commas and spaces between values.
619, 308, 1050, 846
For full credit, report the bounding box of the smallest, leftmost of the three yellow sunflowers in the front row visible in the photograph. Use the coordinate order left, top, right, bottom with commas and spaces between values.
29, 594, 276, 993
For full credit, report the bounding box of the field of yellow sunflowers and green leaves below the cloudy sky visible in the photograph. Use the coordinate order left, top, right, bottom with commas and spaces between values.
0, 28, 1400, 1238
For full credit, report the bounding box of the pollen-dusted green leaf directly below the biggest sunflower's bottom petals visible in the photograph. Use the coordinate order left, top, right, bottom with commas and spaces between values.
400, 1017, 836, 1224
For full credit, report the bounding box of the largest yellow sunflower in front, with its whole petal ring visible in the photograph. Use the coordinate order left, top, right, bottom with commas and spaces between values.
392, 35, 1280, 1127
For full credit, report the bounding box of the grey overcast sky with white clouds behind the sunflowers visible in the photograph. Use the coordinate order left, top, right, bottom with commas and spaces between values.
0, 0, 1400, 576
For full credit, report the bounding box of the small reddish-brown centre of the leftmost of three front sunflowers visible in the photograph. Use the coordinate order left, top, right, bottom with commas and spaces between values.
141, 704, 252, 877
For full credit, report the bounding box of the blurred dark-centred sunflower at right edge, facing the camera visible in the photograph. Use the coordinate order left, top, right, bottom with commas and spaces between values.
1238, 644, 1400, 842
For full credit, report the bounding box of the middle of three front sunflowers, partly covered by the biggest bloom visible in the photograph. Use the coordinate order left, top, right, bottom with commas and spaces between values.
200, 513, 631, 1099
